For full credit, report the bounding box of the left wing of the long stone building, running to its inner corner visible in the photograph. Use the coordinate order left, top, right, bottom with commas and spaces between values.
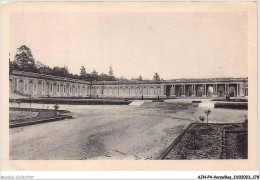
9, 71, 90, 97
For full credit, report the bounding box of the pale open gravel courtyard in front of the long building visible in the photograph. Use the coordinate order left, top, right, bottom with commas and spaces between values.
9, 102, 247, 160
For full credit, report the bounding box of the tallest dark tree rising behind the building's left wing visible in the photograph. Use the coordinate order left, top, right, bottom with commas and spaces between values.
14, 45, 37, 72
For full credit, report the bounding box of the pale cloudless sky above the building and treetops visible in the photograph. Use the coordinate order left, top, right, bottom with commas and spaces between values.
10, 3, 248, 80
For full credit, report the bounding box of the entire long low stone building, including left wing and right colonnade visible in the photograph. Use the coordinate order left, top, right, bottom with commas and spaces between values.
9, 71, 248, 98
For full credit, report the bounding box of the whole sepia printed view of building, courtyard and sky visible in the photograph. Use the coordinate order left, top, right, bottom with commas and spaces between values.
2, 2, 257, 173
